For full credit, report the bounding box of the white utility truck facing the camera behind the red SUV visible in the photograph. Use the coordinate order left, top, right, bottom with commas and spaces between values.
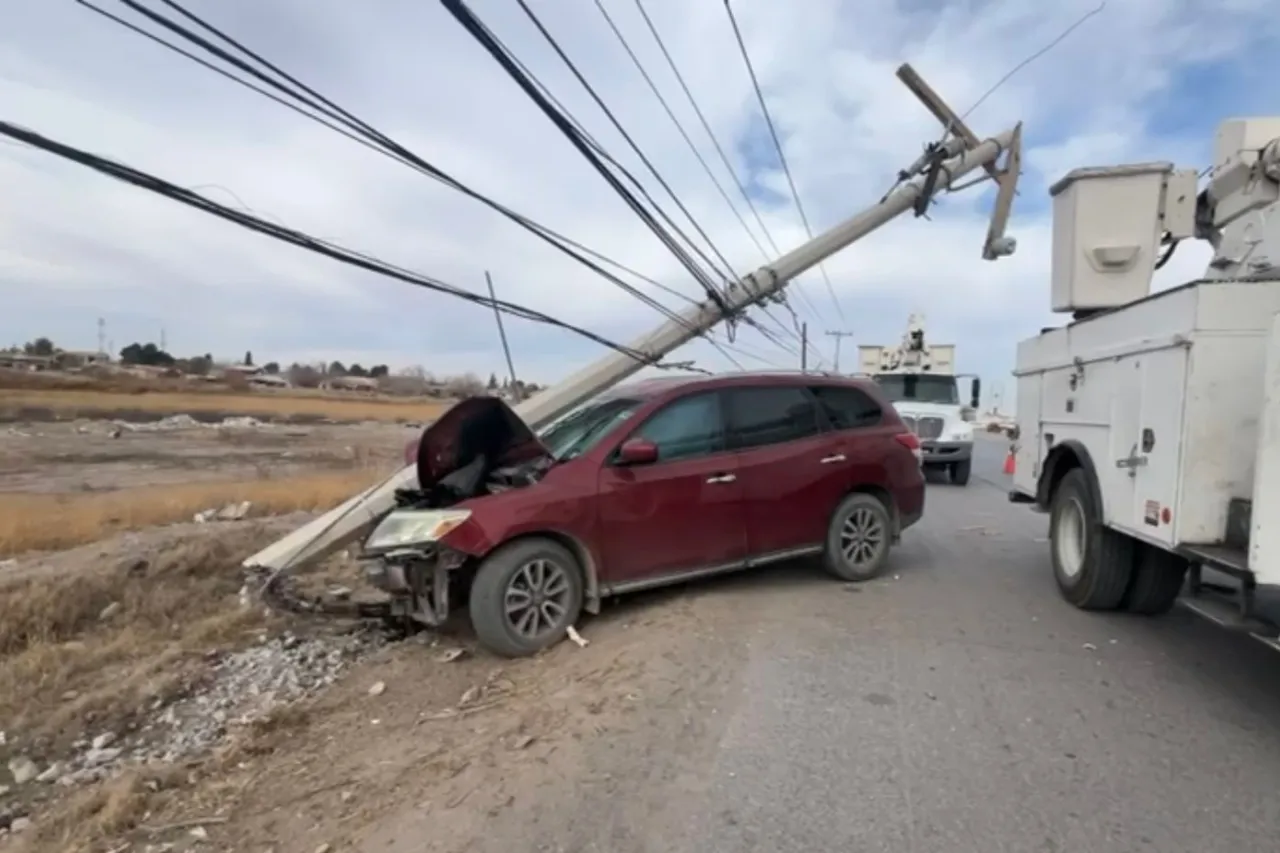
858, 314, 982, 485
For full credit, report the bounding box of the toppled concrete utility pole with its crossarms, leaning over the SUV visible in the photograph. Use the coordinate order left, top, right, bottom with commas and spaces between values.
243, 64, 1021, 616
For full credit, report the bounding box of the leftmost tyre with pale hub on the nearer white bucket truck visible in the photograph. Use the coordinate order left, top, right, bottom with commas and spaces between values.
1048, 467, 1134, 610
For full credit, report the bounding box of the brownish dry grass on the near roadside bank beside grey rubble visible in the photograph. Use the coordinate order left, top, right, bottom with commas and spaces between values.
0, 523, 303, 853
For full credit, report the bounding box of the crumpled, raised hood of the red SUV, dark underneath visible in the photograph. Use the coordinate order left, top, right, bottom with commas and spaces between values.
404, 397, 549, 491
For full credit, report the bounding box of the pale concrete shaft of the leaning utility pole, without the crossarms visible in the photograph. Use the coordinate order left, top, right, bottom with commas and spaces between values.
244, 129, 1015, 571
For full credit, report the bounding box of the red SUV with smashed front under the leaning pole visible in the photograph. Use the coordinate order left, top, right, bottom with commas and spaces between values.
364, 374, 924, 657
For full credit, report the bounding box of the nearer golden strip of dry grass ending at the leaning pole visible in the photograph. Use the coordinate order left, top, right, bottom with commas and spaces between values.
0, 467, 384, 557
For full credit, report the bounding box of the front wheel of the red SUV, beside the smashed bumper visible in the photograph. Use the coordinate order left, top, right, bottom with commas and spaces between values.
468, 537, 584, 657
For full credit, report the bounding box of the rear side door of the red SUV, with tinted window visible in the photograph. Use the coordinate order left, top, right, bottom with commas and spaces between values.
724, 386, 849, 558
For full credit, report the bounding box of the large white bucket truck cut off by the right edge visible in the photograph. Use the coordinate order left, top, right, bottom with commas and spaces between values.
1010, 118, 1280, 648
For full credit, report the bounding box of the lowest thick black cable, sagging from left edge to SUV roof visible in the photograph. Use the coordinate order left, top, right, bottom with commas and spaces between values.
0, 120, 659, 364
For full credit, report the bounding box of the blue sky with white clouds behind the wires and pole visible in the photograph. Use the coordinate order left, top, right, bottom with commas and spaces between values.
0, 0, 1280, 397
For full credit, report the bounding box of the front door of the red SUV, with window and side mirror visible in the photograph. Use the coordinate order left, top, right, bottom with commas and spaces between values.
598, 392, 746, 585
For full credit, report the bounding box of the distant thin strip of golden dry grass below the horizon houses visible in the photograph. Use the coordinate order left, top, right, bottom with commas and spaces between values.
0, 383, 451, 421
